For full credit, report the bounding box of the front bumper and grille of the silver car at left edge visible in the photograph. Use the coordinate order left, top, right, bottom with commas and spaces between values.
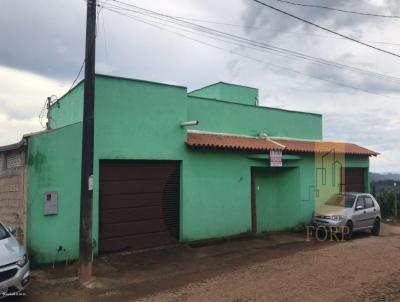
0, 262, 30, 299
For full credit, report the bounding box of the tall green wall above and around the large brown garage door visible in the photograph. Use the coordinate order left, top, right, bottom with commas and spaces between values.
93, 76, 187, 252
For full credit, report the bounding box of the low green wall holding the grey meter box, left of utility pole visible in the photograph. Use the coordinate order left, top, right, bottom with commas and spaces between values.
27, 123, 82, 264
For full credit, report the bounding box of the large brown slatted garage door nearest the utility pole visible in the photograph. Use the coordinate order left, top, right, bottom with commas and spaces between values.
99, 161, 180, 253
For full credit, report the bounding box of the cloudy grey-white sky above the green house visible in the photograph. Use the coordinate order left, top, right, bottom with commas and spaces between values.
0, 0, 400, 173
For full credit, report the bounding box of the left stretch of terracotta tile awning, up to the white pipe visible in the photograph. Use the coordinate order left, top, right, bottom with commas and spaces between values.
186, 132, 284, 151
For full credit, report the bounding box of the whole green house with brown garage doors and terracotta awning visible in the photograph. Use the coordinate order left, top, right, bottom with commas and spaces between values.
0, 75, 377, 263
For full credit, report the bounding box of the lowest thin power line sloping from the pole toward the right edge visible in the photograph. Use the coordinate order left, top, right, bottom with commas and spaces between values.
102, 8, 396, 98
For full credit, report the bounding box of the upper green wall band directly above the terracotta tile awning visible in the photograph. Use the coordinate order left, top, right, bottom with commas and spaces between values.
188, 97, 322, 139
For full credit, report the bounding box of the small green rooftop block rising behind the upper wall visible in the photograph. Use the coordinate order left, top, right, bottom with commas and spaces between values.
189, 82, 258, 106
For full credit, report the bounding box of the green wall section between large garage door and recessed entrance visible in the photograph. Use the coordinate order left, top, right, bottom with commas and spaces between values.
181, 150, 251, 241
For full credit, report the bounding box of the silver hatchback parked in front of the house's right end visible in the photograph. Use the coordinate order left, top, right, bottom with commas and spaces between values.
313, 193, 381, 238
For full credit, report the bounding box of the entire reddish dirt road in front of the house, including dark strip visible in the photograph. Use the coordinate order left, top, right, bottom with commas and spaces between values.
10, 225, 400, 302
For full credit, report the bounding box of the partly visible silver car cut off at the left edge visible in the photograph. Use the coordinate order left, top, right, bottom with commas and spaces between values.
0, 222, 30, 298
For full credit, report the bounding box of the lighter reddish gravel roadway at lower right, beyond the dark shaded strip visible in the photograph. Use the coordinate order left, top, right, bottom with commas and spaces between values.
141, 225, 400, 301
